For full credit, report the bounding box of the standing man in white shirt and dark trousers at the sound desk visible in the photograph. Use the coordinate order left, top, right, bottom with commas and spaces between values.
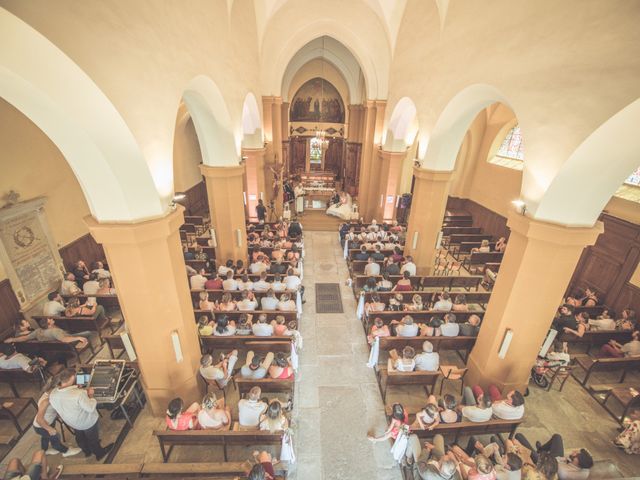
49, 368, 113, 461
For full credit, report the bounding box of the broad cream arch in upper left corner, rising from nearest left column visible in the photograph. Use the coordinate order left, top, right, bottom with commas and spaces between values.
0, 8, 165, 222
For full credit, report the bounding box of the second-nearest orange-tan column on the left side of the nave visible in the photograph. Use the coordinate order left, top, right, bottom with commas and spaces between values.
200, 165, 247, 264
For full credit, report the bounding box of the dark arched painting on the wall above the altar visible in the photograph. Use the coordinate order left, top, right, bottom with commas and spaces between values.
289, 77, 344, 123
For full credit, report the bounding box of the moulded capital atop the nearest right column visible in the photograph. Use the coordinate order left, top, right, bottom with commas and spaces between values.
507, 212, 604, 248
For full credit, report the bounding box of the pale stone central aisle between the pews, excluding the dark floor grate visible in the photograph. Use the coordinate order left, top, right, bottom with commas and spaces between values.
291, 232, 401, 480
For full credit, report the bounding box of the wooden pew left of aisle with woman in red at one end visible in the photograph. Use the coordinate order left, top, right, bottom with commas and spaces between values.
153, 430, 283, 463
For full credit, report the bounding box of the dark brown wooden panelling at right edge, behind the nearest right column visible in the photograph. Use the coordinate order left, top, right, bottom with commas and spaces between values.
567, 214, 640, 314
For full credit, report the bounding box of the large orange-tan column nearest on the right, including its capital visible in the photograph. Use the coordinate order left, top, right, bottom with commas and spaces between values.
465, 212, 604, 392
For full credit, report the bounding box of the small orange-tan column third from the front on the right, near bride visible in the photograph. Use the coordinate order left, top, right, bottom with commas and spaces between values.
372, 150, 407, 222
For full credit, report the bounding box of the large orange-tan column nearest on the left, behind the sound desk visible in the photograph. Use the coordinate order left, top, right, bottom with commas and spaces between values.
85, 206, 200, 416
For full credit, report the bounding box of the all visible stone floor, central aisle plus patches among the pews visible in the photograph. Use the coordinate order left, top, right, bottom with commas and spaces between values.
0, 232, 640, 480
